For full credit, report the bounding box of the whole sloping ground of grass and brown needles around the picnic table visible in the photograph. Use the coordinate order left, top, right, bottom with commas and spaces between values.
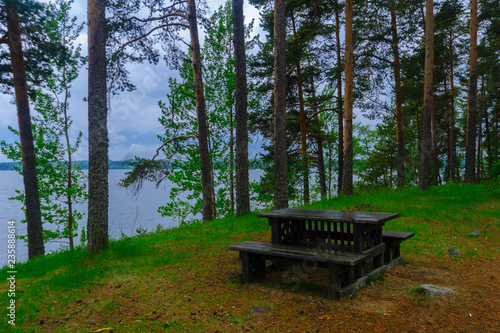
0, 183, 500, 332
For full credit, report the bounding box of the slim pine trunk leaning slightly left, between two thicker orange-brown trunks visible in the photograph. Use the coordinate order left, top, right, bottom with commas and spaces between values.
389, 2, 405, 188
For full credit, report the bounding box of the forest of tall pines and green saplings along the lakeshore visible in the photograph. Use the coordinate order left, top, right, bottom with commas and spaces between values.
0, 0, 500, 258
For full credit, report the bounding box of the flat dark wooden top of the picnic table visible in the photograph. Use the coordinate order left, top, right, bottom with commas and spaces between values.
257, 208, 399, 224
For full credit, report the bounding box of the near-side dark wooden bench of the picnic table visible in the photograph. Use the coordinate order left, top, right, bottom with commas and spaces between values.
229, 241, 387, 299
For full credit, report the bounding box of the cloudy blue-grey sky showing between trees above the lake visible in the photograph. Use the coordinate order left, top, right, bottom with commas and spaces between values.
0, 0, 259, 162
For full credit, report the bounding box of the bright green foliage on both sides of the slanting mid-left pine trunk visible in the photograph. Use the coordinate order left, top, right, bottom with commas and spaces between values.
121, 1, 251, 223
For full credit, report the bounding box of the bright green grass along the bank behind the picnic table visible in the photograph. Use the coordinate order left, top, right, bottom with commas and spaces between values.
0, 184, 500, 331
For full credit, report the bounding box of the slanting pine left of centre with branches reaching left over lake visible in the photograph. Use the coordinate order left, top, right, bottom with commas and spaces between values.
110, 0, 215, 220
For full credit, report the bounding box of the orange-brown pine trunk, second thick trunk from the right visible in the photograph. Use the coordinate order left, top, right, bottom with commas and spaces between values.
419, 0, 434, 190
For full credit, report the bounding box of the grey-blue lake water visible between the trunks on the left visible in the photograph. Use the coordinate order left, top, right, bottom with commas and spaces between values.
0, 170, 262, 267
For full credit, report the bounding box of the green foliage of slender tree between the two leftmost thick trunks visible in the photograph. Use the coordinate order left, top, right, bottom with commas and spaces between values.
0, 0, 87, 245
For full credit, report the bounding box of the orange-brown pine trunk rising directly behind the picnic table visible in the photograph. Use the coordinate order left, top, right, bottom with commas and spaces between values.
342, 0, 354, 195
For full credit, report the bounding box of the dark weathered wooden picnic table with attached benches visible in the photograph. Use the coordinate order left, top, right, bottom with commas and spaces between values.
229, 208, 413, 298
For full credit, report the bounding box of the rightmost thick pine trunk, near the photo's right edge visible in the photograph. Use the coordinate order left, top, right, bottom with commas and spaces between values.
465, 0, 477, 183
